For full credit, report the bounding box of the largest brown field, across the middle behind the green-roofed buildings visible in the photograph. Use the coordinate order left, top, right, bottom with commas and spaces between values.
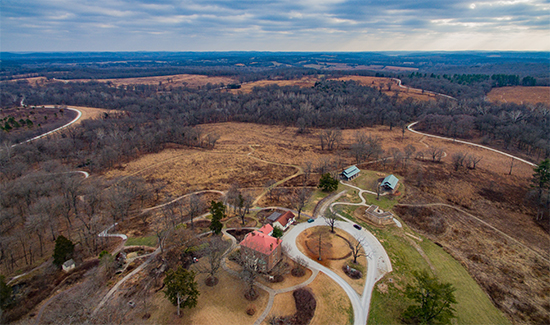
106, 123, 532, 200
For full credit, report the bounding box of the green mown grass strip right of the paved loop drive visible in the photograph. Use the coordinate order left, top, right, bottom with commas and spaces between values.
361, 219, 509, 324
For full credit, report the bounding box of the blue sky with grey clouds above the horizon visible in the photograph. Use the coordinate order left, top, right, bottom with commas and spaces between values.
0, 0, 550, 52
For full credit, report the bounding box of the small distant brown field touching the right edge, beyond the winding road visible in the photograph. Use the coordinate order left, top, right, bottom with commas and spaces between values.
487, 86, 550, 104
